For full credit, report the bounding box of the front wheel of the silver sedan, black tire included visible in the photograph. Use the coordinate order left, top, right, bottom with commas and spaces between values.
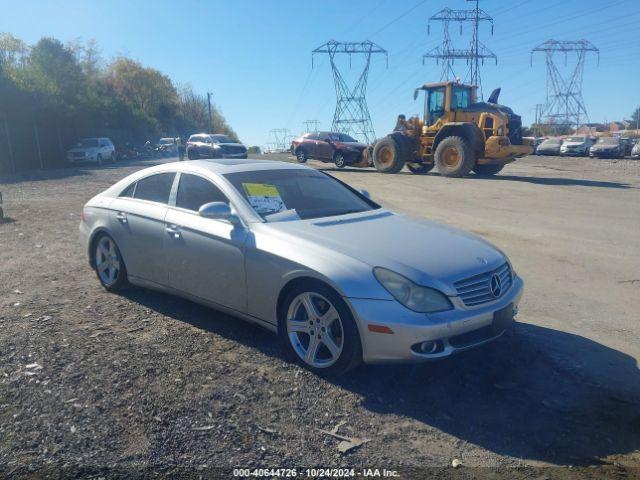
278, 281, 362, 376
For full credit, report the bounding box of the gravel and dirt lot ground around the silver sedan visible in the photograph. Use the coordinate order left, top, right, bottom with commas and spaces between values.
0, 157, 640, 478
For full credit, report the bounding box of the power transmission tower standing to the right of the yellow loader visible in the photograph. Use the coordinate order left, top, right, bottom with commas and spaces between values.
531, 40, 600, 130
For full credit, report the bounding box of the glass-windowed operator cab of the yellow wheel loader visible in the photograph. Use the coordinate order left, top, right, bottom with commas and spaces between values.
413, 82, 476, 126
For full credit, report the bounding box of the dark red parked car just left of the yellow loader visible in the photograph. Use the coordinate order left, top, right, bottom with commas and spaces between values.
291, 132, 367, 168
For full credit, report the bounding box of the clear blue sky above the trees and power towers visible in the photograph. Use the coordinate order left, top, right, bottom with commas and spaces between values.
0, 0, 640, 146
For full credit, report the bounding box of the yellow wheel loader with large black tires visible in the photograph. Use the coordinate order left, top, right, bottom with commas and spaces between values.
367, 81, 533, 177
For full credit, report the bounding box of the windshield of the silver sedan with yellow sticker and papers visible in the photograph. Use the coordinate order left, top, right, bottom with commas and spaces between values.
224, 169, 380, 222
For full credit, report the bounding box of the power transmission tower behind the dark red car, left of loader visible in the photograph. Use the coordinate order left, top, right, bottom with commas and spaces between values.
311, 40, 389, 143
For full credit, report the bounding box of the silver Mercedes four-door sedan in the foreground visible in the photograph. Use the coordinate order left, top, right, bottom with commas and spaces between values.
80, 160, 523, 374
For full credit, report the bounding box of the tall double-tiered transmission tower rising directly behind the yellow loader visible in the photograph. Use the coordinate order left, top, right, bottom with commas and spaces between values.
422, 0, 498, 96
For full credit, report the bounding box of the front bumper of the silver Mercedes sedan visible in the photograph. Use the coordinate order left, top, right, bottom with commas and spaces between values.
347, 276, 524, 363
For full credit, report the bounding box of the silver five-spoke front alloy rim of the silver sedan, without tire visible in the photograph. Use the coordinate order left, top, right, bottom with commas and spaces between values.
286, 292, 345, 368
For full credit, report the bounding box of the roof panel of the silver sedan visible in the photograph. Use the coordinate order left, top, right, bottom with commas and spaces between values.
142, 158, 309, 175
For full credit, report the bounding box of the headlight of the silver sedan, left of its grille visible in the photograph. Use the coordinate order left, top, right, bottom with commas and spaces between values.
373, 267, 453, 313
